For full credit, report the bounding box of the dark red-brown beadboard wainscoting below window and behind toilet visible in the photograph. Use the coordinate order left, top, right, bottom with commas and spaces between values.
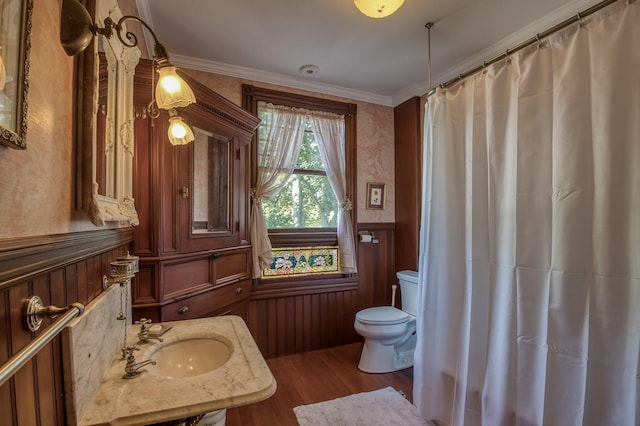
247, 223, 397, 358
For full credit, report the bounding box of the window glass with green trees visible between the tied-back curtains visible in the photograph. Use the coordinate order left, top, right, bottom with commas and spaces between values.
258, 109, 339, 229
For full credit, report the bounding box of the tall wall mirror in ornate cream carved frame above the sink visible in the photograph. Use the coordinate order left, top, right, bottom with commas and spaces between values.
77, 0, 140, 226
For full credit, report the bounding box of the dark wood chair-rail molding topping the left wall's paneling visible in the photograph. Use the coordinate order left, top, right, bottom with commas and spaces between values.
0, 228, 133, 290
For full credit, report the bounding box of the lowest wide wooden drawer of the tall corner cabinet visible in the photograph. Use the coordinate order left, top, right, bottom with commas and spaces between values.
161, 280, 251, 321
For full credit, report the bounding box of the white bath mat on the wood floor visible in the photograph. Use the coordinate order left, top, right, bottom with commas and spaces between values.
293, 387, 428, 426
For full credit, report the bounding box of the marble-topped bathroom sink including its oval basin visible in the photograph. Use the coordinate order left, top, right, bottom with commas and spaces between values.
78, 315, 277, 426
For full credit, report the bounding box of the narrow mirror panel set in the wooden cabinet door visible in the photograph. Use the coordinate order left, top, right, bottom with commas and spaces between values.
191, 126, 232, 234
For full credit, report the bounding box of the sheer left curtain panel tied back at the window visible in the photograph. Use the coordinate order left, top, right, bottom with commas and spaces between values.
251, 102, 305, 278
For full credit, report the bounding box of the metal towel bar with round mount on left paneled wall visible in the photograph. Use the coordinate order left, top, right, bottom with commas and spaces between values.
0, 296, 84, 386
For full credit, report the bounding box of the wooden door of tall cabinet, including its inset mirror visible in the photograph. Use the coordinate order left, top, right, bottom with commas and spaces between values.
176, 113, 246, 253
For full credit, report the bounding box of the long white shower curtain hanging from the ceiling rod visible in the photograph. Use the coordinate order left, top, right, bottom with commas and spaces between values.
414, 2, 640, 426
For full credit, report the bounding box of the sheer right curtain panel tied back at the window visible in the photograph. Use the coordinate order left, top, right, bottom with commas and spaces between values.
310, 111, 358, 273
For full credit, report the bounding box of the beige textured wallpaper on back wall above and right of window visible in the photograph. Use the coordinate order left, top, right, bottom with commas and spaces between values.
183, 70, 395, 223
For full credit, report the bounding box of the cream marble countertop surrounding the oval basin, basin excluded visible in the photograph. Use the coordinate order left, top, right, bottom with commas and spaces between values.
80, 316, 276, 425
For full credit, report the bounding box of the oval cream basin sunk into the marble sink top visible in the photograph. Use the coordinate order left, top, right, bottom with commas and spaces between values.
147, 337, 233, 378
